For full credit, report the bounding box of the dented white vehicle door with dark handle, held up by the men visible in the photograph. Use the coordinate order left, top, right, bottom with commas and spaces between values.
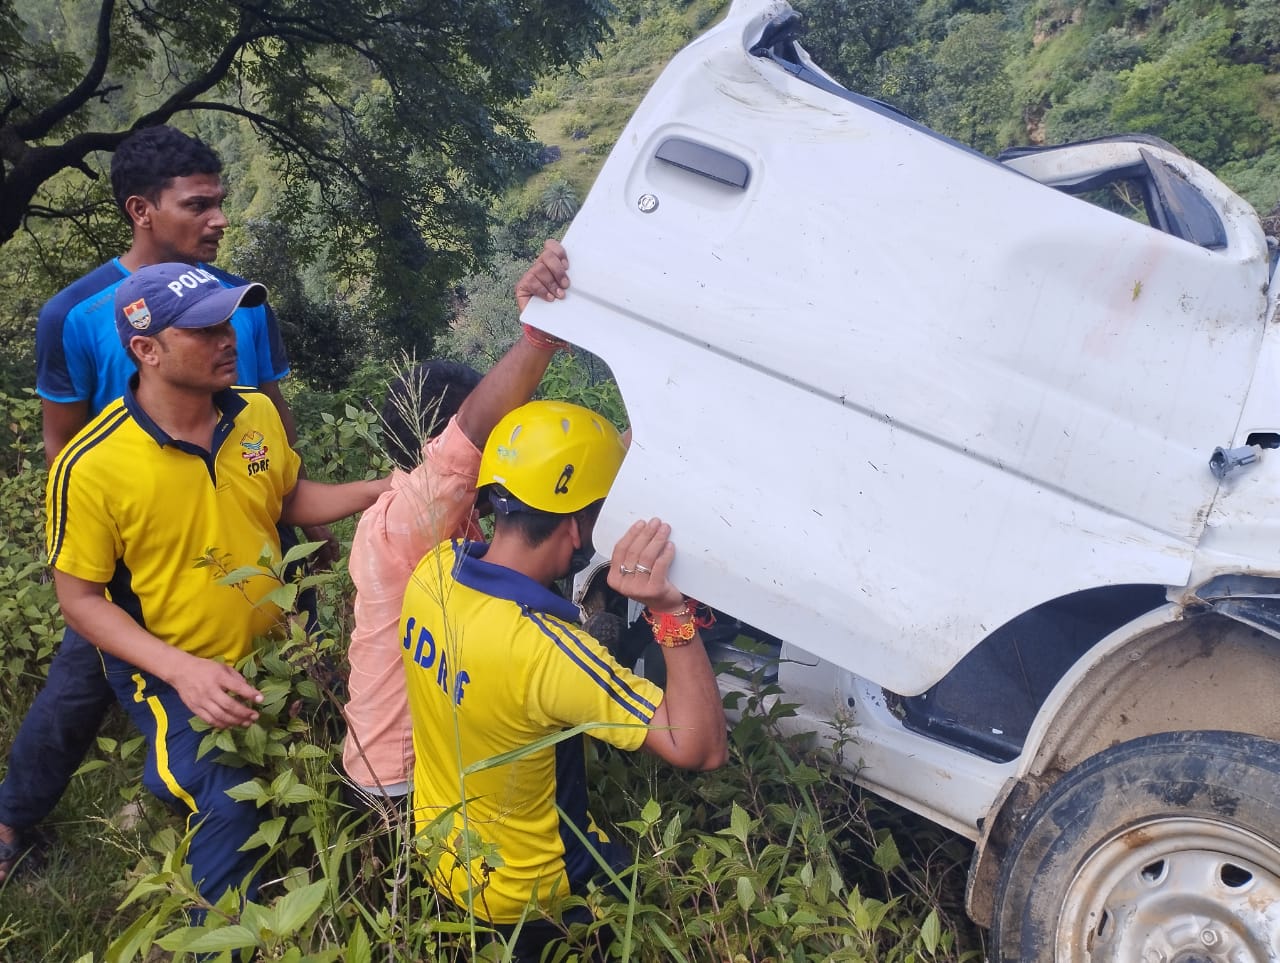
526, 3, 1266, 694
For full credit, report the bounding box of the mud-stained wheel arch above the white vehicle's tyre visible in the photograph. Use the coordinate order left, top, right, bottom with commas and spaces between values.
965, 607, 1280, 926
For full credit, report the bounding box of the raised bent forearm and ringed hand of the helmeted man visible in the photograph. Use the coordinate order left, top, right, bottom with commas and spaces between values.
608, 519, 728, 770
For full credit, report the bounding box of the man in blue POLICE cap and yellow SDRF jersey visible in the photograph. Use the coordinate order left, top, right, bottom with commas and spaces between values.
46, 264, 388, 902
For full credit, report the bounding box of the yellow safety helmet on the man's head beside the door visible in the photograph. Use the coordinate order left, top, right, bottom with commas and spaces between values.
476, 401, 626, 515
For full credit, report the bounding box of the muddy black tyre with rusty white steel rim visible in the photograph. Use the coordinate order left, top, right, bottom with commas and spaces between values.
992, 731, 1280, 963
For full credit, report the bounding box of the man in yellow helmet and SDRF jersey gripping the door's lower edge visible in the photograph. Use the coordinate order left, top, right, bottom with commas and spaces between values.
401, 401, 727, 960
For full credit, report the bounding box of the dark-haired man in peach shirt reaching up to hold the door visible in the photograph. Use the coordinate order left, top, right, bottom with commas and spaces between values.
342, 241, 568, 811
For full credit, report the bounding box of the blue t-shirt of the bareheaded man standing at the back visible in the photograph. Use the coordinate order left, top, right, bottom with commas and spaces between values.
36, 257, 289, 417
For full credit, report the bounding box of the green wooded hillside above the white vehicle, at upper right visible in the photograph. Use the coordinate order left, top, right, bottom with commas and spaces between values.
796, 0, 1280, 213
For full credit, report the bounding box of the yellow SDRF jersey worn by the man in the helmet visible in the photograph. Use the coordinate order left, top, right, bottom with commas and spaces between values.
401, 542, 662, 923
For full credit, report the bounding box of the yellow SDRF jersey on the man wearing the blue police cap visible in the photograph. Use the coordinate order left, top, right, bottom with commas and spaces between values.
45, 388, 300, 662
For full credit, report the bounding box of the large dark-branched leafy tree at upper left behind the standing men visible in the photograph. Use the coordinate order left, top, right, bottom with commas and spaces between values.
0, 0, 608, 379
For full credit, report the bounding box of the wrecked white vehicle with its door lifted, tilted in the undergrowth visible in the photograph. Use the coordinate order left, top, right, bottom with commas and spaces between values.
527, 0, 1280, 963
